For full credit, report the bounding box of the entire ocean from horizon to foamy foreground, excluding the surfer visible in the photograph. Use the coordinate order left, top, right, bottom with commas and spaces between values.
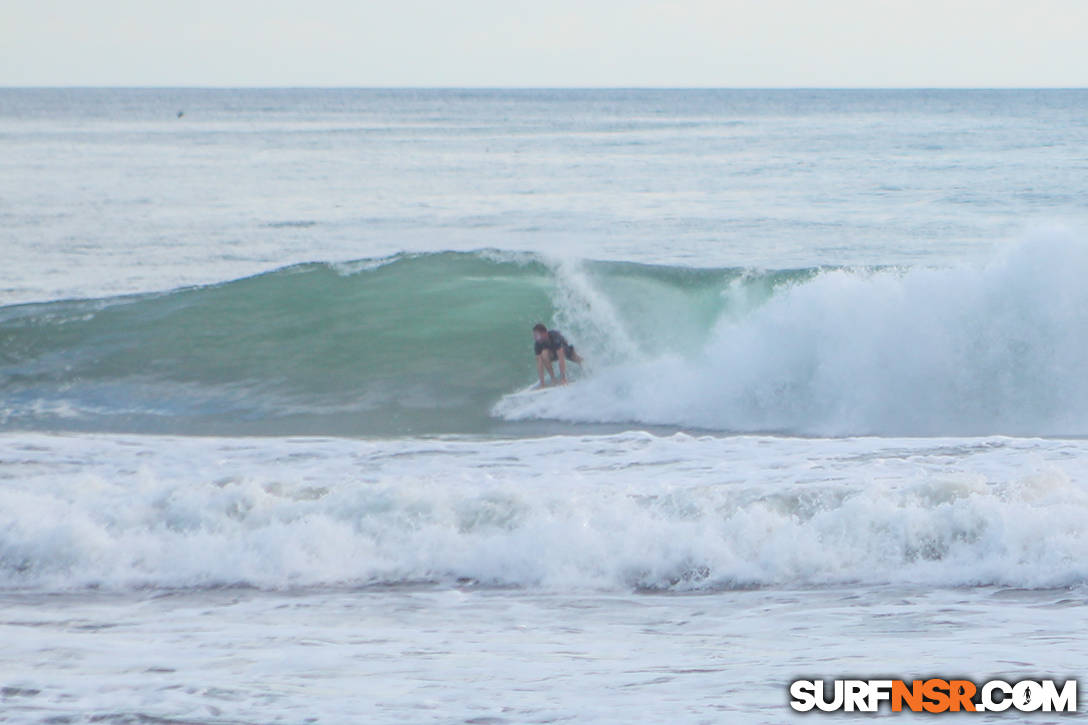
0, 88, 1088, 725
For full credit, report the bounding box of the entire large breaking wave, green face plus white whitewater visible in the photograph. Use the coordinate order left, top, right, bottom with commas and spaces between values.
8, 242, 1088, 435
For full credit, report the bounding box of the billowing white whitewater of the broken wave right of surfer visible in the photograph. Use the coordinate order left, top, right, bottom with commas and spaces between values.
496, 238, 1088, 435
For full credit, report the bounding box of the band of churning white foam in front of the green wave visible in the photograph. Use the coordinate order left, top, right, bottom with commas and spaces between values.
0, 433, 1088, 590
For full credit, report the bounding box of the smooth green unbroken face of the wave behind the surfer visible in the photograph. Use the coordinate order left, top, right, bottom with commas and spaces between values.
0, 253, 770, 435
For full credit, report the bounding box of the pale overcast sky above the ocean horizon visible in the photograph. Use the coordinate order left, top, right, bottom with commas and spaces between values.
6, 0, 1088, 87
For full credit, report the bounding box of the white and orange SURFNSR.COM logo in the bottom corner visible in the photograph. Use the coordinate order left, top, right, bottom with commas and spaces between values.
790, 677, 1077, 713
